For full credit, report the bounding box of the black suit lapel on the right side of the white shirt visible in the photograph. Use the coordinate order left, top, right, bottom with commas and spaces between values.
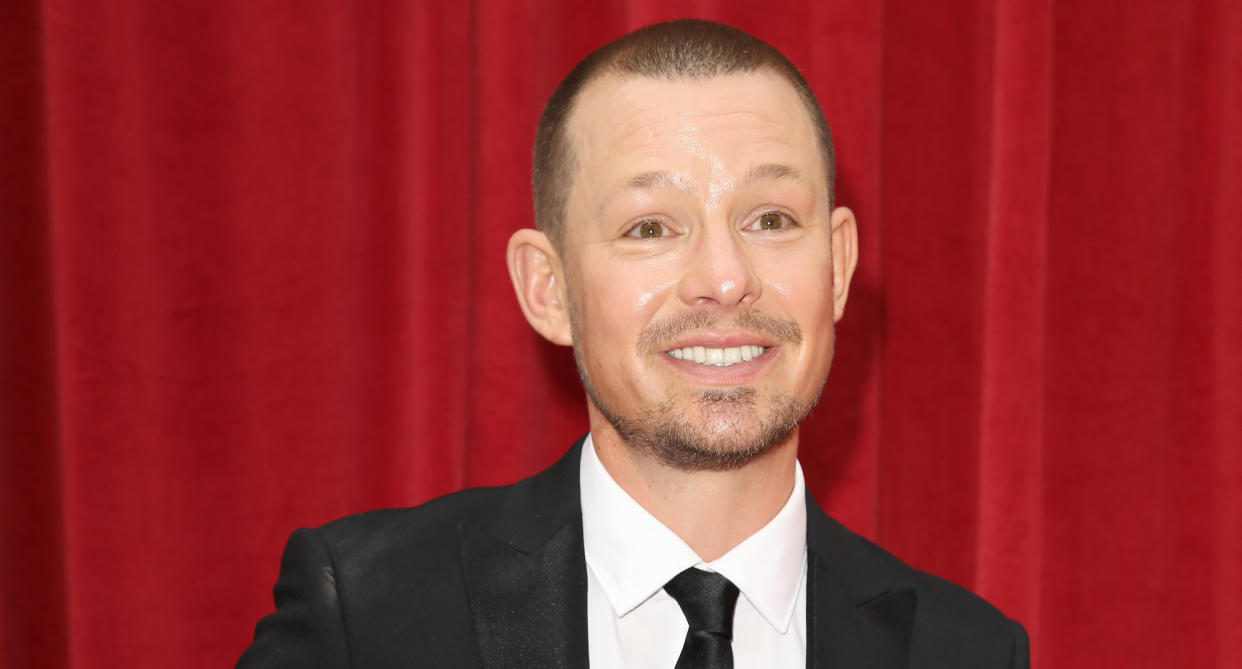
806, 495, 918, 669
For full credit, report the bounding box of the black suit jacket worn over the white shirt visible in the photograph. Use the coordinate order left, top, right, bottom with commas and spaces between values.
237, 439, 1028, 669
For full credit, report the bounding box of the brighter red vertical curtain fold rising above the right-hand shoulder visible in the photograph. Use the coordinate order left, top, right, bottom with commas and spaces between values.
975, 0, 1053, 638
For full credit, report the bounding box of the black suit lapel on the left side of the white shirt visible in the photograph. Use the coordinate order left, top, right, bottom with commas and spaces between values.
457, 439, 587, 668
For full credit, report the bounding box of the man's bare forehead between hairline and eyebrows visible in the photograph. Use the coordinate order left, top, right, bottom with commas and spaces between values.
568, 71, 827, 212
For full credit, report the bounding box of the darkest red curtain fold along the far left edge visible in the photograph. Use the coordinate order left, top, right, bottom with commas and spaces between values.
0, 2, 70, 667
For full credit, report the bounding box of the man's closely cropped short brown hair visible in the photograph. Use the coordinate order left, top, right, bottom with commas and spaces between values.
530, 19, 836, 249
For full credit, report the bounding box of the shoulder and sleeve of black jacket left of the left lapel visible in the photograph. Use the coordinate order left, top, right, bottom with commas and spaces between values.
237, 488, 514, 669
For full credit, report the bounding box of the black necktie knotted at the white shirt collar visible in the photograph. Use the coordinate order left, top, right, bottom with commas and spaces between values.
664, 567, 738, 669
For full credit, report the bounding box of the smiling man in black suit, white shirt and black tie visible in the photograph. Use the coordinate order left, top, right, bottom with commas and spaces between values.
238, 21, 1027, 668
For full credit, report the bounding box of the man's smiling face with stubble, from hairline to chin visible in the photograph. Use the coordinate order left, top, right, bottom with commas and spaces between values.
563, 72, 853, 469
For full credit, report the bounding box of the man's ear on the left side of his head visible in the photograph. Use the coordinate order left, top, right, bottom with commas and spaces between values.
505, 228, 574, 346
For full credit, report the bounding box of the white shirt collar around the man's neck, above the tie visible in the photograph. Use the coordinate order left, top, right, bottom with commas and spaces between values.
579, 434, 806, 634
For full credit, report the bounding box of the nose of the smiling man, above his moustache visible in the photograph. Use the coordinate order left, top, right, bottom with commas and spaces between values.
678, 222, 763, 309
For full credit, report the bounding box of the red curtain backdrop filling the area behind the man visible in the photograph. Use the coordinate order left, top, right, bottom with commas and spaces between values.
0, 0, 1242, 669
